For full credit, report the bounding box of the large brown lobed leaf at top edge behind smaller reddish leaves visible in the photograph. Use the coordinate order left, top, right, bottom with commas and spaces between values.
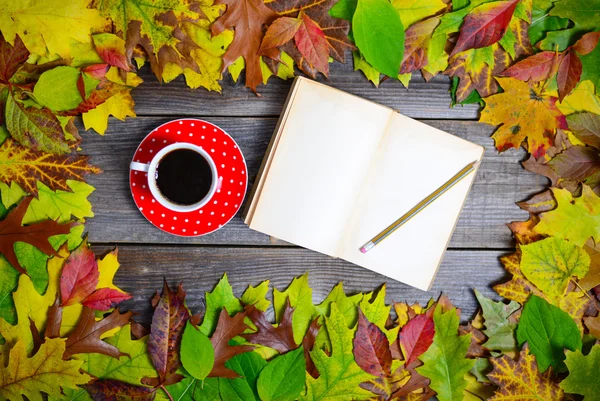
267, 0, 354, 78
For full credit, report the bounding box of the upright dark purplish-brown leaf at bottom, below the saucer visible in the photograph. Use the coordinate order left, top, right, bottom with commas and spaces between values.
142, 280, 190, 384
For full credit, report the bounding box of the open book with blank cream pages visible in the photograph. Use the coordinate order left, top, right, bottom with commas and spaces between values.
245, 77, 484, 290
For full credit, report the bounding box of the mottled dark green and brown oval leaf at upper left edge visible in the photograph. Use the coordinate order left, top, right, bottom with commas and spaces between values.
4, 90, 70, 154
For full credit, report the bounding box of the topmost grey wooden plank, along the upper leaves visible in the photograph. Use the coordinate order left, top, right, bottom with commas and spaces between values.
133, 61, 479, 119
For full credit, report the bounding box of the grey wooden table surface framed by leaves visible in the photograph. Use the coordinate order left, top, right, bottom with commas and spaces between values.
83, 63, 547, 323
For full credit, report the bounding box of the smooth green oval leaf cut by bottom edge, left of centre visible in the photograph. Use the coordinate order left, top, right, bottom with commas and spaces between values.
257, 347, 306, 401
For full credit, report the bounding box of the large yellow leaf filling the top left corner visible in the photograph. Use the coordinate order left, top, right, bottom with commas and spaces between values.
0, 0, 106, 58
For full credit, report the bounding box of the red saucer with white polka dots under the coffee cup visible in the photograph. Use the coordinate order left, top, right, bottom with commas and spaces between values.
129, 118, 248, 237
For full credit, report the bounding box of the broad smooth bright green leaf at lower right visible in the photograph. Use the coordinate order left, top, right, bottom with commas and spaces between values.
517, 295, 581, 373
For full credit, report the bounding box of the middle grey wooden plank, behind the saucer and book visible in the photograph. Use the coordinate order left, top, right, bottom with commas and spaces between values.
83, 117, 546, 248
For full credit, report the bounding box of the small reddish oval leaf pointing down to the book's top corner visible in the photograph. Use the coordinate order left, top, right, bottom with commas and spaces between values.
294, 14, 329, 76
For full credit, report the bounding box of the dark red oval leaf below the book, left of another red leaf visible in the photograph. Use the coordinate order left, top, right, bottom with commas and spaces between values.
352, 309, 392, 376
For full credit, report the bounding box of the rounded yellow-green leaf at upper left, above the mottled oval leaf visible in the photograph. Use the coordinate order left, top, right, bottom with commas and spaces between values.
33, 66, 83, 111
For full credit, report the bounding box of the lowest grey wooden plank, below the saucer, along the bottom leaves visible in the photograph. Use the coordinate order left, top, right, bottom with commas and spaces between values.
94, 245, 508, 324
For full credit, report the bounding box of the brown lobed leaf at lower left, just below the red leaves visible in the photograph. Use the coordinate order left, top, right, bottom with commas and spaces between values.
64, 306, 133, 359
